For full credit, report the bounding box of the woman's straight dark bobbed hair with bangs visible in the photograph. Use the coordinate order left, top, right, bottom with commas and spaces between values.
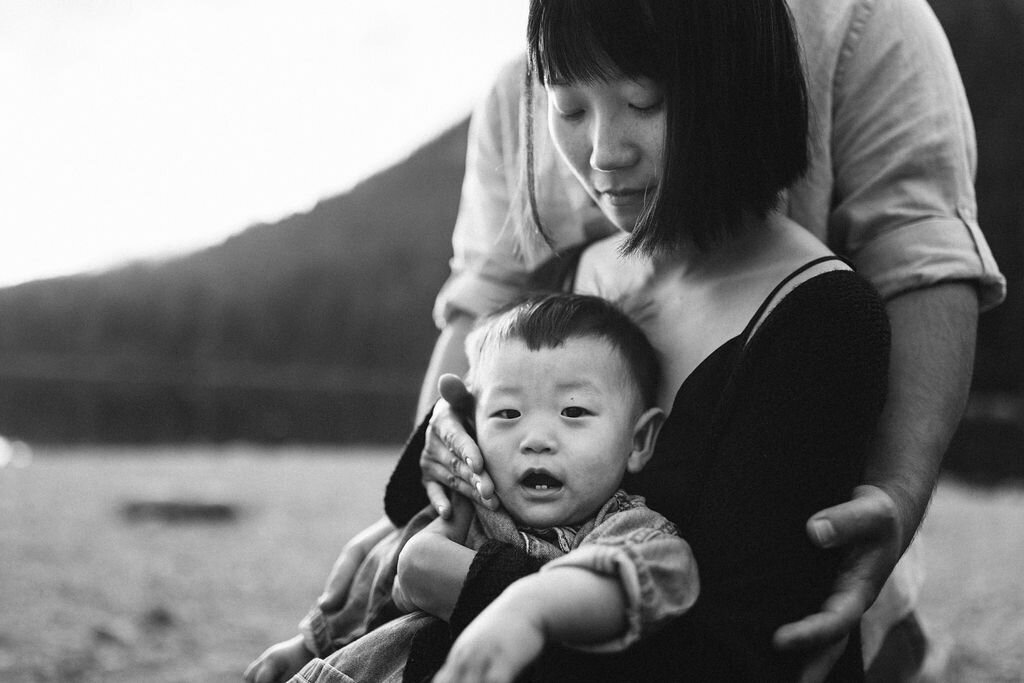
527, 0, 808, 254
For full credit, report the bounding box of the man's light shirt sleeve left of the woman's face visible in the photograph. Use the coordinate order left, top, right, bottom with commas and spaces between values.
434, 56, 615, 328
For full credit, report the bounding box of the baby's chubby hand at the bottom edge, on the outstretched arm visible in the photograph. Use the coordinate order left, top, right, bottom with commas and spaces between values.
434, 603, 545, 683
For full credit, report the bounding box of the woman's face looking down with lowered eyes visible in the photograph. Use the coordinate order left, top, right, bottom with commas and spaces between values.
547, 77, 666, 231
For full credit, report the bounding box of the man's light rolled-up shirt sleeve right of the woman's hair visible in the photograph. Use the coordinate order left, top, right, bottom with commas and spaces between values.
828, 0, 1006, 309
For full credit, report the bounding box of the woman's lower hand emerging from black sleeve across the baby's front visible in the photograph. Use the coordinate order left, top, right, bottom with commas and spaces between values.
391, 495, 476, 622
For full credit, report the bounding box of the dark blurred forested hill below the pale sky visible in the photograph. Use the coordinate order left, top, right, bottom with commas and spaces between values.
0, 0, 1024, 459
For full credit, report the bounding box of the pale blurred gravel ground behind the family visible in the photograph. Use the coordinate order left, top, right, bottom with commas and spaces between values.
0, 445, 1024, 683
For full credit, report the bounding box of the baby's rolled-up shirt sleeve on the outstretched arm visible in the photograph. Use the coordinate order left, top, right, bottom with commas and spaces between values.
541, 507, 700, 652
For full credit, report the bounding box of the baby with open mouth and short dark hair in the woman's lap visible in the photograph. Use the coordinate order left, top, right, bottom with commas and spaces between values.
246, 294, 698, 683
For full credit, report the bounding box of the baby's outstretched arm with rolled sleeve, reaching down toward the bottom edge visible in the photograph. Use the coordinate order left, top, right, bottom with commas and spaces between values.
435, 507, 699, 681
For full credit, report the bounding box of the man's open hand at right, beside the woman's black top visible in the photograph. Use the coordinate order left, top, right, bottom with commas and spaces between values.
774, 485, 904, 683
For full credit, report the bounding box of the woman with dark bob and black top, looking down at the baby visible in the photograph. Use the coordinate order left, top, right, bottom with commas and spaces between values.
388, 0, 888, 680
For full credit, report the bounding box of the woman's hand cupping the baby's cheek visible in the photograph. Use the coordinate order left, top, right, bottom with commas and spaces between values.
420, 375, 499, 519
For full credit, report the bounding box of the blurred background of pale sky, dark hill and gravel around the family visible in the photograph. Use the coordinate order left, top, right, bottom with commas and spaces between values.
0, 0, 1024, 681
